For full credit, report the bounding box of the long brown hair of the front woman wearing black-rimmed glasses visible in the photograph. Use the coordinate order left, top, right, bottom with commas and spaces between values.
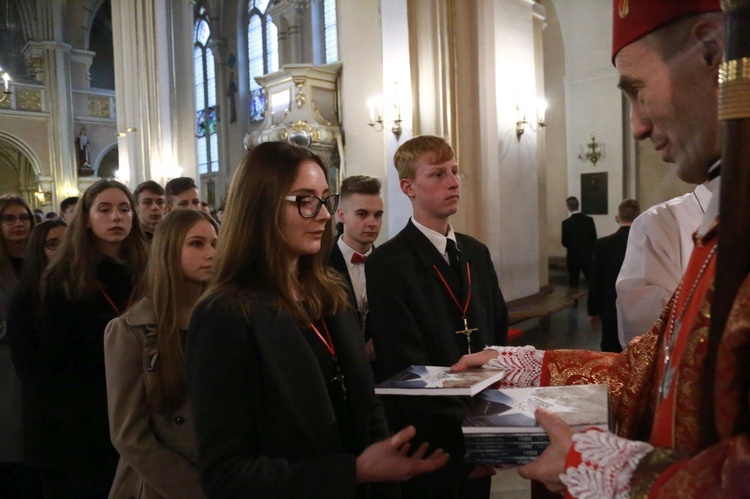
205, 142, 347, 326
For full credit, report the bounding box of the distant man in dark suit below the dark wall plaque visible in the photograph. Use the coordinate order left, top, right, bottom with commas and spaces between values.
562, 196, 596, 288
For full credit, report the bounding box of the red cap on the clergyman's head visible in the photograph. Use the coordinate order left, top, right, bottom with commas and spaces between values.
612, 0, 721, 62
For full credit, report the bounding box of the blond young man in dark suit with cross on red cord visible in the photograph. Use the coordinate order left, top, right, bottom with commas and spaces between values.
365, 136, 508, 499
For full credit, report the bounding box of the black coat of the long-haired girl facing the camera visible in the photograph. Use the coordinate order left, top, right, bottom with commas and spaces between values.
39, 259, 132, 495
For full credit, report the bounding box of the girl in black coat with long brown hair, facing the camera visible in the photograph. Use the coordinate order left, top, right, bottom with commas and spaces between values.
39, 180, 147, 497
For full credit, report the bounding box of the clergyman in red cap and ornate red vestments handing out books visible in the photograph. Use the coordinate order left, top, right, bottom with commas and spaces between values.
454, 0, 750, 498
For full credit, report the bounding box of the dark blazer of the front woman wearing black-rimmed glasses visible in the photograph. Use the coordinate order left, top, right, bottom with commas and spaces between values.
186, 297, 398, 498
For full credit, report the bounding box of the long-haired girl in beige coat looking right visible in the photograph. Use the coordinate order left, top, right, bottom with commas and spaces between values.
104, 210, 218, 499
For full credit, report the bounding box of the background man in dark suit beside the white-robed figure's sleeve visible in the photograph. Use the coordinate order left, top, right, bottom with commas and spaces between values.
588, 199, 641, 353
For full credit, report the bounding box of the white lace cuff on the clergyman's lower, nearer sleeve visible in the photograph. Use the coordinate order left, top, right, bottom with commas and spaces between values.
560, 429, 654, 499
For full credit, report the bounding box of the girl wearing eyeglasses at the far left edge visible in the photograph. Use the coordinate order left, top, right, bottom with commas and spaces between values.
0, 194, 34, 497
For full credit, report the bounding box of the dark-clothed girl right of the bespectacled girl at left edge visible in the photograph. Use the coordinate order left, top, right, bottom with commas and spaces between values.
7, 220, 67, 497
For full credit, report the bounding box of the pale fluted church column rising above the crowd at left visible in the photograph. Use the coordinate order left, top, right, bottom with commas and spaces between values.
112, 0, 197, 188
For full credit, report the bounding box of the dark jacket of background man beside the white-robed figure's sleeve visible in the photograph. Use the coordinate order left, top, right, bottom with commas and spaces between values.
588, 225, 630, 321
